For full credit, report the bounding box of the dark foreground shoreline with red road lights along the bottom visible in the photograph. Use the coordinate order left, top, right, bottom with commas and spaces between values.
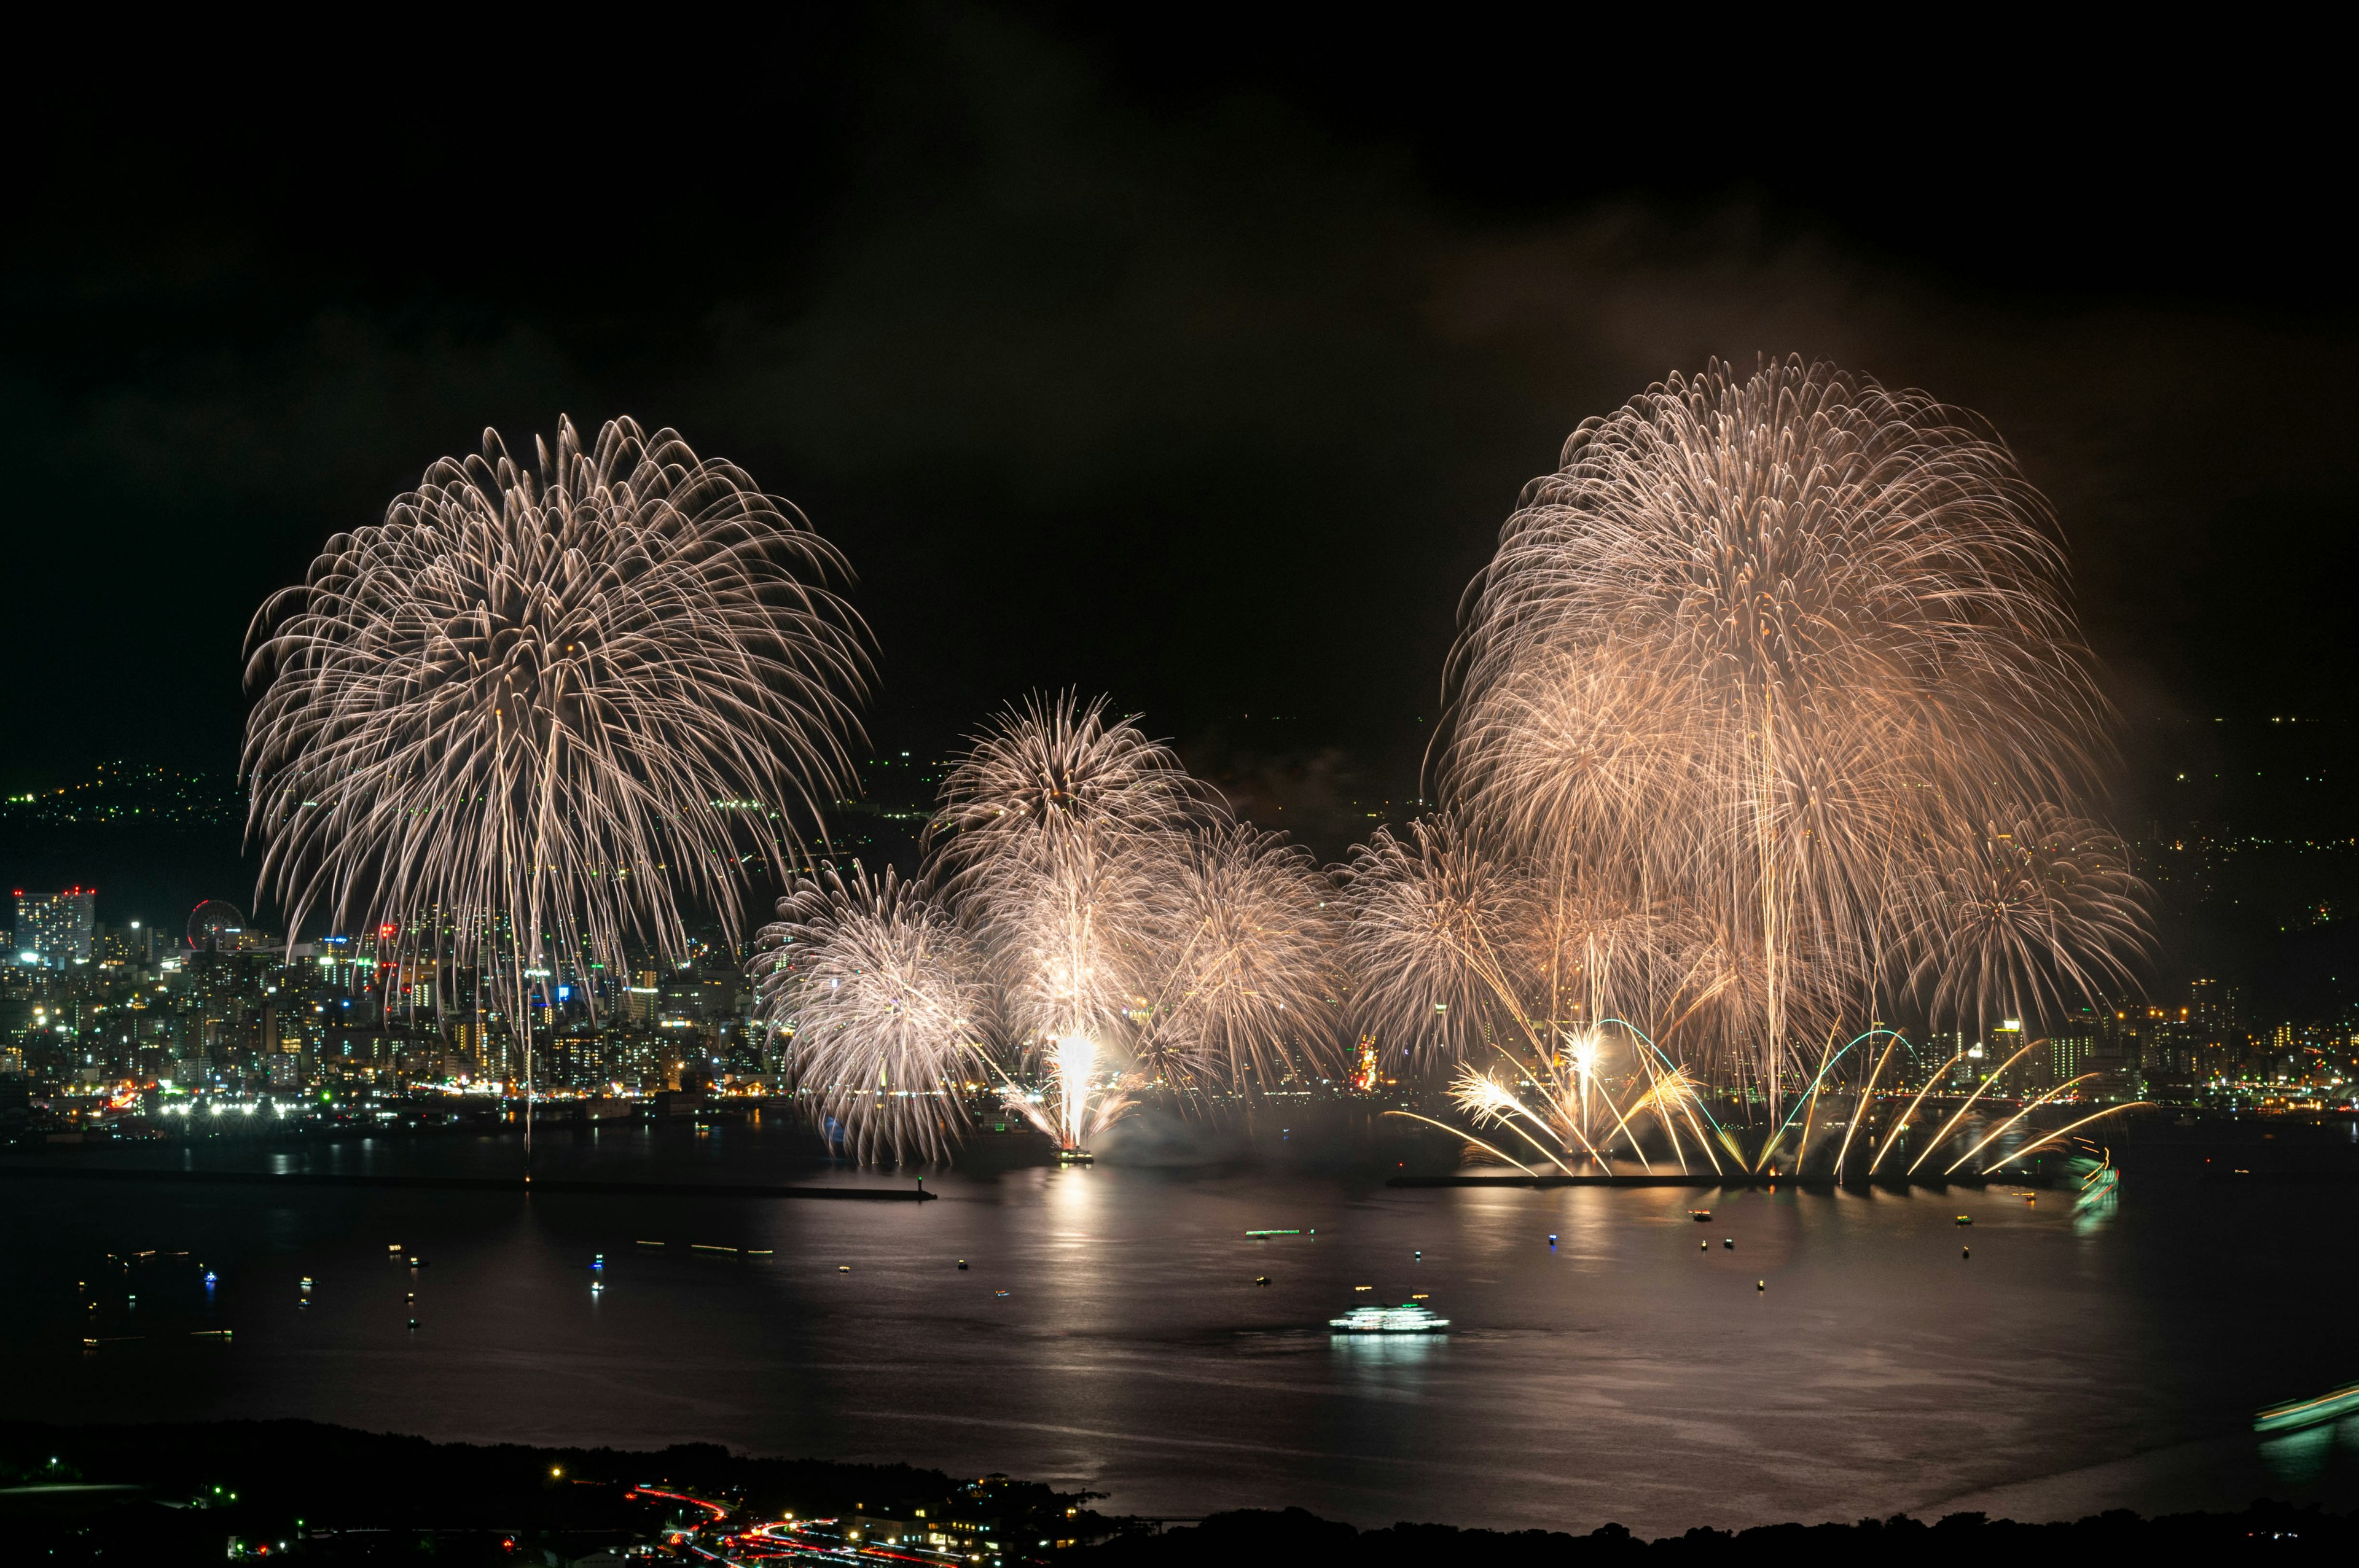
0, 1422, 2359, 1568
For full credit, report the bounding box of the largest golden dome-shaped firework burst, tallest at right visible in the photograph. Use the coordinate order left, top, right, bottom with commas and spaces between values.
1444, 361, 2135, 1110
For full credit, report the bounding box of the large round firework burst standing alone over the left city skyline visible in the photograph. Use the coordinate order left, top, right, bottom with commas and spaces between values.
243, 419, 868, 1150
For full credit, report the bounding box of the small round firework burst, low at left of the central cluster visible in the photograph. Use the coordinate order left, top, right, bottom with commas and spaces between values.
755, 865, 995, 1160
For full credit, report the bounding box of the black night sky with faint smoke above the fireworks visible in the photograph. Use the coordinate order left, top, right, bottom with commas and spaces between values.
0, 7, 2359, 919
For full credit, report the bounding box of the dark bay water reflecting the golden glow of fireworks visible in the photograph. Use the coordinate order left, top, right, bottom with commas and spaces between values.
0, 1129, 2359, 1532
